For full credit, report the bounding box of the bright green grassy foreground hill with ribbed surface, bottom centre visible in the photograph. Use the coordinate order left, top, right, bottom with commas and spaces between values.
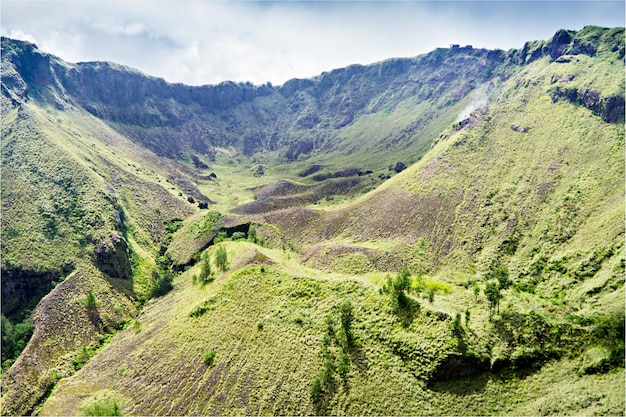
41, 239, 624, 415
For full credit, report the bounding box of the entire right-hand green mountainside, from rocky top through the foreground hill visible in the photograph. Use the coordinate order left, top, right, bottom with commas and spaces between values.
30, 28, 625, 415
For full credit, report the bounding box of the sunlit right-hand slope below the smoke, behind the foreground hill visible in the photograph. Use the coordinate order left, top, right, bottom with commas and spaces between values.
265, 51, 624, 292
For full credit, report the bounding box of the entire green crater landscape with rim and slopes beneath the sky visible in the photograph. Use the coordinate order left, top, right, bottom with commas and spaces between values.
2, 27, 625, 415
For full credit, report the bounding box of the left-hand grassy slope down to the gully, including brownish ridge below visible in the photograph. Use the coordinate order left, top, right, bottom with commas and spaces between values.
2, 96, 197, 414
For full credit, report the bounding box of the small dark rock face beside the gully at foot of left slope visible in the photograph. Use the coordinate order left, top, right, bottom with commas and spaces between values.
94, 232, 132, 278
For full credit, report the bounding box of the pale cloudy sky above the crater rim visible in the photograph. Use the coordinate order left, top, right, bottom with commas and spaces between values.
0, 0, 625, 85
